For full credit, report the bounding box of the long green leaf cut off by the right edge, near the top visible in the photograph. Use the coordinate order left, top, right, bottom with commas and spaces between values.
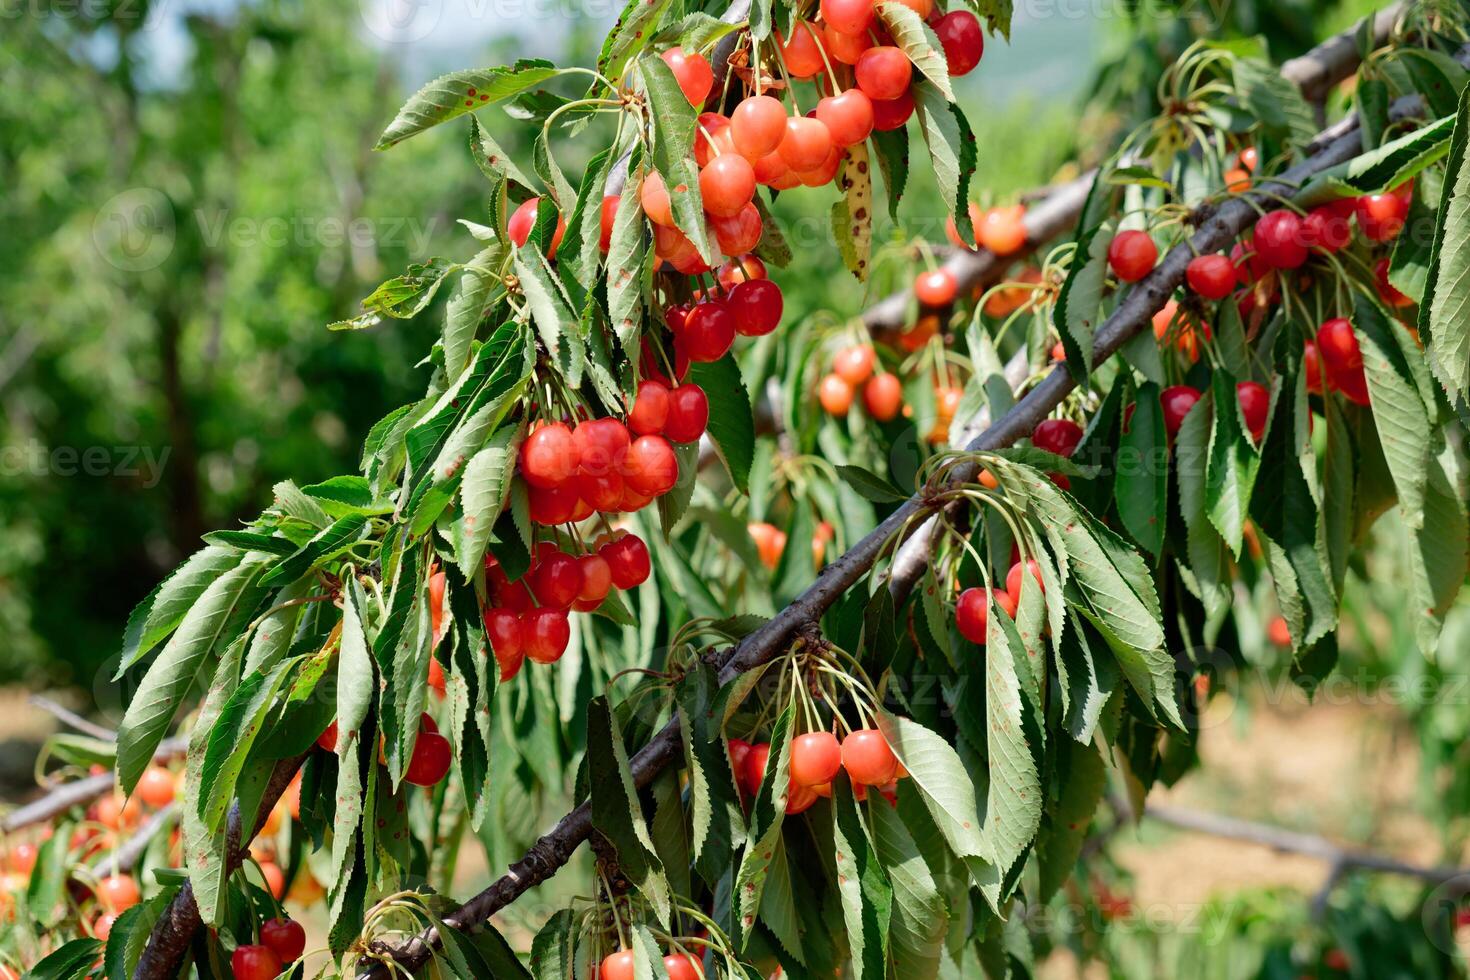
1411, 80, 1470, 403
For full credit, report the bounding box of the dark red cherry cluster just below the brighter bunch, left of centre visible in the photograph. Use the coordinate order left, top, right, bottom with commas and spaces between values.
485, 530, 651, 680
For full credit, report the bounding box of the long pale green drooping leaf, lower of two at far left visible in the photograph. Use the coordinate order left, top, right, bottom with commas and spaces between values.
118, 560, 268, 793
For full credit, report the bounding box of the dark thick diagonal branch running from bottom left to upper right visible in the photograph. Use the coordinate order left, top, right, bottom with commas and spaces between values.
349, 28, 1419, 980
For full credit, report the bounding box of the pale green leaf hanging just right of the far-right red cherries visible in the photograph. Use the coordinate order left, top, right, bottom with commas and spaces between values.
1354, 294, 1430, 529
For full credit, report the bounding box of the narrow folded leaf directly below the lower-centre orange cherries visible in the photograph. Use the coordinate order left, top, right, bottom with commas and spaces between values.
832, 777, 894, 980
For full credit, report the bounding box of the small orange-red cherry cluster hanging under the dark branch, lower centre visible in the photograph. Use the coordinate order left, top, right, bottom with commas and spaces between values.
729, 729, 907, 815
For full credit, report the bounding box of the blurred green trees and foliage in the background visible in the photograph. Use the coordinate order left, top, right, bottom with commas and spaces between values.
0, 0, 1470, 977
